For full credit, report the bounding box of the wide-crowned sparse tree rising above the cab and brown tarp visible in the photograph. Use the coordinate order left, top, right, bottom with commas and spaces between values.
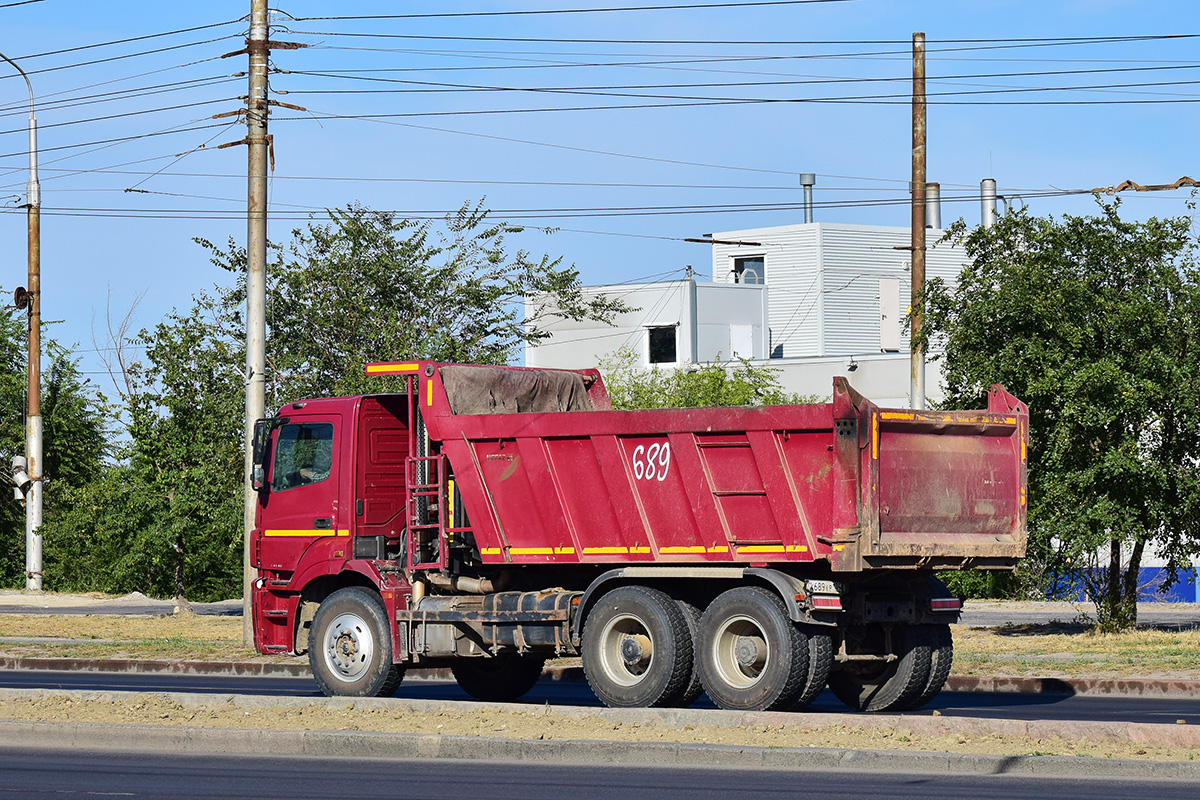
198, 205, 625, 402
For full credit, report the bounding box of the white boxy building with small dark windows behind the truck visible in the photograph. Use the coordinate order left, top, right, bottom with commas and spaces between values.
526, 222, 967, 407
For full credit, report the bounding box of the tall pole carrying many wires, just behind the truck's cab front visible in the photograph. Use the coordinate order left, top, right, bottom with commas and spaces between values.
241, 0, 270, 644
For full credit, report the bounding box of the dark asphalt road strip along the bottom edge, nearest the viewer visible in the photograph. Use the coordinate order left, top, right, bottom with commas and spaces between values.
0, 750, 1200, 800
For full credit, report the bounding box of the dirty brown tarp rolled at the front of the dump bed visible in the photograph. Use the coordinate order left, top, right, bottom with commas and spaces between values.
442, 366, 594, 414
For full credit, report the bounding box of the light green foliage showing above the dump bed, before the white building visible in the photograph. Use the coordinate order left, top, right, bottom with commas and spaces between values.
600, 347, 818, 410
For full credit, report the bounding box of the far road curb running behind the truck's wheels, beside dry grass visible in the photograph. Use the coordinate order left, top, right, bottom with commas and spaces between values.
7, 656, 1200, 698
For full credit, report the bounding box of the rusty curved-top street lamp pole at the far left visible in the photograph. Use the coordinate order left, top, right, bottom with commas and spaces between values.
0, 53, 42, 591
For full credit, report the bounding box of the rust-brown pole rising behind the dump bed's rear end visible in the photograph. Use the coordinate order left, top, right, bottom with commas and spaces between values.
908, 34, 925, 409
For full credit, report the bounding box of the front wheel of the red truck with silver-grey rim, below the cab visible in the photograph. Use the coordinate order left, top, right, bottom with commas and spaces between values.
308, 587, 404, 697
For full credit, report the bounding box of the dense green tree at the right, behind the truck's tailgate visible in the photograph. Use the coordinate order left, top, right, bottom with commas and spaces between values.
925, 203, 1200, 630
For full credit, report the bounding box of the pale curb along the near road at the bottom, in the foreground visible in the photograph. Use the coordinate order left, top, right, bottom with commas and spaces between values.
0, 722, 1200, 781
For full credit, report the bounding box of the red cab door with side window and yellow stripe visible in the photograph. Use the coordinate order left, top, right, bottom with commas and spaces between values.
258, 414, 349, 572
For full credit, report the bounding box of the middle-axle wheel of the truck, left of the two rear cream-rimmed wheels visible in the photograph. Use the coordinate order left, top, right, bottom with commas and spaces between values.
582, 587, 694, 708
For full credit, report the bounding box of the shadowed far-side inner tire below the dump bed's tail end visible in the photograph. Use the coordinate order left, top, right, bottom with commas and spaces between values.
829, 624, 931, 711
